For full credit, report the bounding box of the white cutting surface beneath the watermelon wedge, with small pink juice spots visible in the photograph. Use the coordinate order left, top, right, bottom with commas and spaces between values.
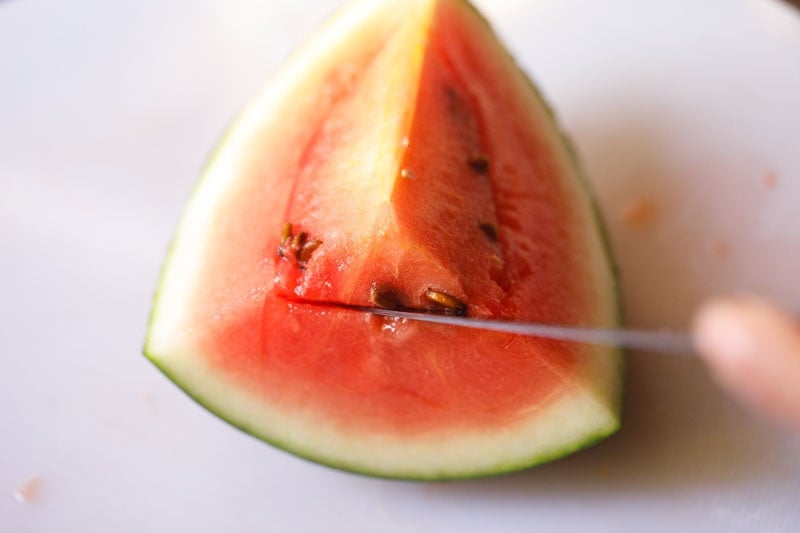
0, 0, 800, 533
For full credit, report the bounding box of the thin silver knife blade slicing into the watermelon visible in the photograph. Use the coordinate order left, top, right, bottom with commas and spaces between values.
342, 305, 694, 355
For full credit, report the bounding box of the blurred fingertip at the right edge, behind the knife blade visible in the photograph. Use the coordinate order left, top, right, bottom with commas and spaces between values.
693, 296, 800, 428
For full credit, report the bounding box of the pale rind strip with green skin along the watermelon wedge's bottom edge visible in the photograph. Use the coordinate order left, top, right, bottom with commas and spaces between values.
145, 340, 621, 481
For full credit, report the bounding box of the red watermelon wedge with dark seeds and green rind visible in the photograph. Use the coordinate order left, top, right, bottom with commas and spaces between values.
145, 0, 622, 479
